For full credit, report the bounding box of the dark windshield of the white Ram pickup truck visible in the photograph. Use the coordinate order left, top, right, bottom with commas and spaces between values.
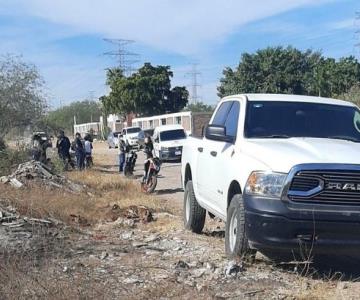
244, 101, 360, 142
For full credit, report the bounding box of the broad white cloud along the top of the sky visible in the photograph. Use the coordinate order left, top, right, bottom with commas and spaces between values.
3, 0, 329, 55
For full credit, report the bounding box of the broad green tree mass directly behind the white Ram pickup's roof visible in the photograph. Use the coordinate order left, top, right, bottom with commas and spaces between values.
218, 47, 360, 97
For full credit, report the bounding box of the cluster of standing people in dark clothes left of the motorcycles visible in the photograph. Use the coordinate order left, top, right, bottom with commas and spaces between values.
56, 130, 93, 170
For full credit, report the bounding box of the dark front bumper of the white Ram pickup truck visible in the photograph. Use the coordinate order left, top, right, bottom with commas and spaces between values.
244, 195, 360, 253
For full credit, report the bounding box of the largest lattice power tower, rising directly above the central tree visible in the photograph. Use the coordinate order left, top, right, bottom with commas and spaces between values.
104, 39, 140, 76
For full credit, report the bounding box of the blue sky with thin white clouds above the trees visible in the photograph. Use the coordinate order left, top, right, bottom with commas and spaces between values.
0, 0, 360, 108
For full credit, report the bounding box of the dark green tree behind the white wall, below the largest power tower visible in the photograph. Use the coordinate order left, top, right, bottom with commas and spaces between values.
101, 63, 189, 116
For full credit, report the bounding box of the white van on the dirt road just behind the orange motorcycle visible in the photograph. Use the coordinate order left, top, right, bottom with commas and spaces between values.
153, 125, 186, 161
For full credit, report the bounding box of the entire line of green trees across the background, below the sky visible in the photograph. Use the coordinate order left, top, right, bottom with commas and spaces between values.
0, 47, 360, 144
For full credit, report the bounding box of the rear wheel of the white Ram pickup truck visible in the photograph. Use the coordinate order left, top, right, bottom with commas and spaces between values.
183, 180, 206, 233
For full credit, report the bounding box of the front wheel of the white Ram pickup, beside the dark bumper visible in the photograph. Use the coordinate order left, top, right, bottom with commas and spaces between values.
225, 195, 256, 258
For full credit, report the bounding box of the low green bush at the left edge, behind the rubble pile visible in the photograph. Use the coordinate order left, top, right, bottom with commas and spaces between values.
0, 145, 30, 176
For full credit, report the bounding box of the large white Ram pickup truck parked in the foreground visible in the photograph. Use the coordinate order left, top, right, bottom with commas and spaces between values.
181, 94, 360, 257
